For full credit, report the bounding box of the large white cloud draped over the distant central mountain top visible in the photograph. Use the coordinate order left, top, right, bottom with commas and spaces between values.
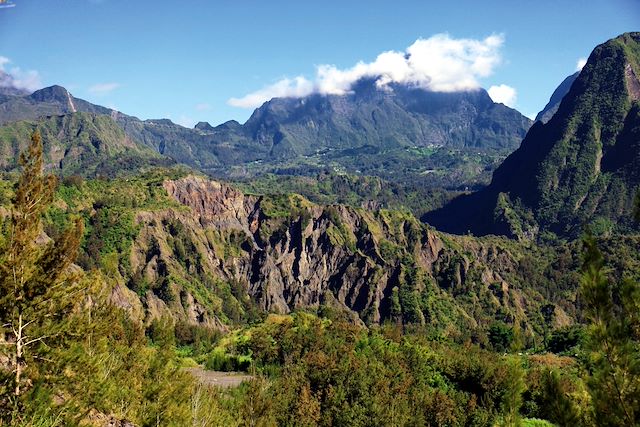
228, 34, 504, 108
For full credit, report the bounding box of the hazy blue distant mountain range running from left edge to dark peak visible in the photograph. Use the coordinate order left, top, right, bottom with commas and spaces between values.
0, 81, 531, 188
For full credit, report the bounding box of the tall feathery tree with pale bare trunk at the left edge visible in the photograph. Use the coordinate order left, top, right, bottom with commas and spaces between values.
0, 131, 83, 423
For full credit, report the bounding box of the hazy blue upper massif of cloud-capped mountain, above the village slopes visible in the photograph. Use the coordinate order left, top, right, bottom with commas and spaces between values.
243, 80, 531, 156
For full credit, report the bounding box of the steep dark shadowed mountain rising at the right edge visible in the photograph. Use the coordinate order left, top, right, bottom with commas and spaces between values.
425, 33, 640, 241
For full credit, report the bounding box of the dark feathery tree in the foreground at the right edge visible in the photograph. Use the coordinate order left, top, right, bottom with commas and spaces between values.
580, 237, 640, 426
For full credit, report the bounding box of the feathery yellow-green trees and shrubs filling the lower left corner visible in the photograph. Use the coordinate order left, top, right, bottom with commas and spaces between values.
0, 133, 192, 426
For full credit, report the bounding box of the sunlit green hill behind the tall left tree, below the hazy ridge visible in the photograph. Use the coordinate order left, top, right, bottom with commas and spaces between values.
0, 113, 174, 177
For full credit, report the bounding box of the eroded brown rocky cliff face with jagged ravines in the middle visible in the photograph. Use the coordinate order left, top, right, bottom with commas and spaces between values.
119, 176, 566, 342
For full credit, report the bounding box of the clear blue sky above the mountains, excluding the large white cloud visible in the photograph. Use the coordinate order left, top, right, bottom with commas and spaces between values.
0, 0, 640, 125
